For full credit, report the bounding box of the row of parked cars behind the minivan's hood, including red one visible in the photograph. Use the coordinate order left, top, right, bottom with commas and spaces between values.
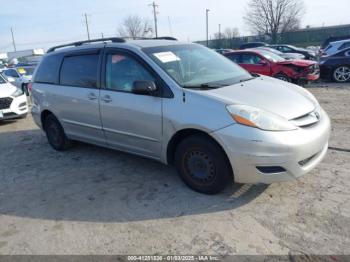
216, 39, 350, 85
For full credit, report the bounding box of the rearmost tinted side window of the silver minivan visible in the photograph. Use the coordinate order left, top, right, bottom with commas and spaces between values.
34, 55, 61, 84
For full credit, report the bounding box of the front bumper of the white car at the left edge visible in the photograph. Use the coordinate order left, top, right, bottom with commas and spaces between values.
0, 94, 28, 120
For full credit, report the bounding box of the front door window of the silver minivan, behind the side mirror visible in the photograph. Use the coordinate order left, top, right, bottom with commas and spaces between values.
106, 53, 155, 92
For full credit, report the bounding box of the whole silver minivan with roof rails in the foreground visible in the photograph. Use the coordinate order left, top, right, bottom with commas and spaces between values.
32, 38, 330, 194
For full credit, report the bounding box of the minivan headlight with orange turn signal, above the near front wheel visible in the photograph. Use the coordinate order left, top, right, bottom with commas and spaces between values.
226, 105, 296, 131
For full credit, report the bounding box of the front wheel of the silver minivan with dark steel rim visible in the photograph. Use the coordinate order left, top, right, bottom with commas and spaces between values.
174, 136, 233, 194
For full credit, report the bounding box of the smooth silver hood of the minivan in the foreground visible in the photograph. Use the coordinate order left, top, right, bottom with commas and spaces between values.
206, 77, 316, 120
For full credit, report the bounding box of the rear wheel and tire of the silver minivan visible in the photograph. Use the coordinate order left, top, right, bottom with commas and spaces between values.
44, 114, 72, 151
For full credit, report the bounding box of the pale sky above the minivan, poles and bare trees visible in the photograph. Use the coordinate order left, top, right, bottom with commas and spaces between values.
0, 0, 350, 53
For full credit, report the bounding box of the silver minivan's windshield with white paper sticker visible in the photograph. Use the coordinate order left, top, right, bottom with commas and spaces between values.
143, 44, 252, 88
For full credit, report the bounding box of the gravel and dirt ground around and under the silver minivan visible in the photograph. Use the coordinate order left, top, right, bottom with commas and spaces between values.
0, 84, 350, 255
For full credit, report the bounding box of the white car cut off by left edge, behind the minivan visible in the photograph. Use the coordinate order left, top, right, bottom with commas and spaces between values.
0, 72, 28, 121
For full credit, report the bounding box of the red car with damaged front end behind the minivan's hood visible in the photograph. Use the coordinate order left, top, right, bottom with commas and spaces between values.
224, 49, 320, 84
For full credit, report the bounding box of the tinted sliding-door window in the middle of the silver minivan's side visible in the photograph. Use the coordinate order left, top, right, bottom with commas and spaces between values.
60, 54, 99, 88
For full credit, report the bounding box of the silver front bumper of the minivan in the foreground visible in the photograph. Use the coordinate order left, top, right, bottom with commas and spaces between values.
212, 107, 330, 184
